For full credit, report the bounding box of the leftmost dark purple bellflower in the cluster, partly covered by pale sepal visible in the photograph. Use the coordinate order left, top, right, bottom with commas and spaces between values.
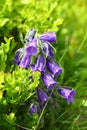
14, 48, 24, 65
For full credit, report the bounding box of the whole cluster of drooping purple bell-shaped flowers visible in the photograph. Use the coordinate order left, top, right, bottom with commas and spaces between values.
14, 29, 75, 114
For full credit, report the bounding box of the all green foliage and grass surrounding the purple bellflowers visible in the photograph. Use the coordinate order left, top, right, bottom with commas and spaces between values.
0, 0, 87, 130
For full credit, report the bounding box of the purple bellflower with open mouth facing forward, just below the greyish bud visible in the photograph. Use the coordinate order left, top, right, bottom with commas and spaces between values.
25, 39, 38, 56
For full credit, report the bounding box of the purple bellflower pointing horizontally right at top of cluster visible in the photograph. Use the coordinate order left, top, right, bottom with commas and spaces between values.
39, 32, 56, 42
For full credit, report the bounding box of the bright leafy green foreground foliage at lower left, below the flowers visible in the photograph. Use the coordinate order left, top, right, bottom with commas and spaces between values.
0, 68, 40, 129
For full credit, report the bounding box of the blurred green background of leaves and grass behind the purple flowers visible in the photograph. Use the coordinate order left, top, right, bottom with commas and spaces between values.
0, 0, 87, 130
